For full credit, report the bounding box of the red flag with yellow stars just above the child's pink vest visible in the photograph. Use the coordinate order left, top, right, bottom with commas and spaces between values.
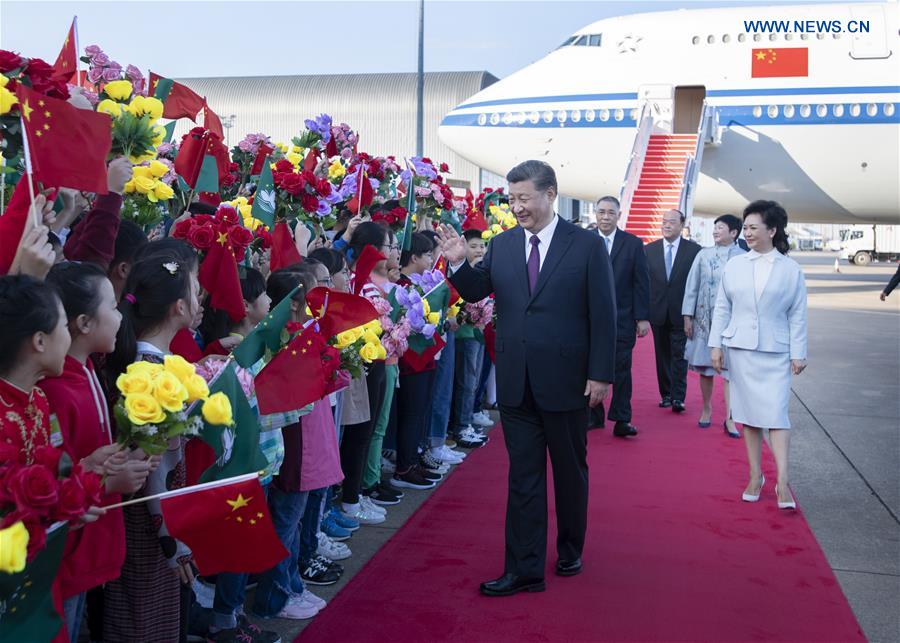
254, 324, 326, 415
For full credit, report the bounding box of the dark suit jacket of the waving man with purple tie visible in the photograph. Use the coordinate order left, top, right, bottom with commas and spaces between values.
450, 219, 616, 412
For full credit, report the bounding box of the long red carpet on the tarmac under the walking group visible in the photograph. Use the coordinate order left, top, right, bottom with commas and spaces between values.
298, 338, 865, 643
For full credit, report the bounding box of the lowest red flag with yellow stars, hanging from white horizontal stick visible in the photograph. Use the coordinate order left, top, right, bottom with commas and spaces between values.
160, 473, 288, 576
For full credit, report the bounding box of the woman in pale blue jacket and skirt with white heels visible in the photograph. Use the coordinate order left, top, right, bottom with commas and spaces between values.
709, 201, 806, 509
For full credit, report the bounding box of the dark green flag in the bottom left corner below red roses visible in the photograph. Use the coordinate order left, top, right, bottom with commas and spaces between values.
0, 523, 69, 643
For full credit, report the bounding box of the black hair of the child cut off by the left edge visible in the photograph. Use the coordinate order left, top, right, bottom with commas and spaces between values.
0, 275, 59, 374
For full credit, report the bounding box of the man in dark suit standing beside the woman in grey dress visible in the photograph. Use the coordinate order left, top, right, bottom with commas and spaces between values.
644, 210, 700, 413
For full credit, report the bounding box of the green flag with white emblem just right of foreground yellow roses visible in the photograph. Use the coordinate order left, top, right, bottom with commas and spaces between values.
194, 362, 268, 482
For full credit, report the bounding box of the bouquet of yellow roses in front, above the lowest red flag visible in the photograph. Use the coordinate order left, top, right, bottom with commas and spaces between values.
113, 355, 234, 455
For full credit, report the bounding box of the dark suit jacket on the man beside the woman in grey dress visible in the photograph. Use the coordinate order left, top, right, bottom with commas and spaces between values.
644, 239, 700, 326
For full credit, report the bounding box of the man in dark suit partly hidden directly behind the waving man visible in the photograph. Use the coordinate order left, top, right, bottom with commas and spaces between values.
592, 196, 650, 438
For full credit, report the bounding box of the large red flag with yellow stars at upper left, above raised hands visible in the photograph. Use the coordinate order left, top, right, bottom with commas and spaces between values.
16, 83, 112, 194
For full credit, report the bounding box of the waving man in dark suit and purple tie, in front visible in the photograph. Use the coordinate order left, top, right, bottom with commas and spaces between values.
439, 161, 616, 596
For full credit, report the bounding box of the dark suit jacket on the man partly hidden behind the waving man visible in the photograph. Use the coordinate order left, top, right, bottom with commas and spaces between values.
597, 230, 650, 346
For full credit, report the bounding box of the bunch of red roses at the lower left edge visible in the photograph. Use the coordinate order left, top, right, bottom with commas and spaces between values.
0, 445, 102, 562
